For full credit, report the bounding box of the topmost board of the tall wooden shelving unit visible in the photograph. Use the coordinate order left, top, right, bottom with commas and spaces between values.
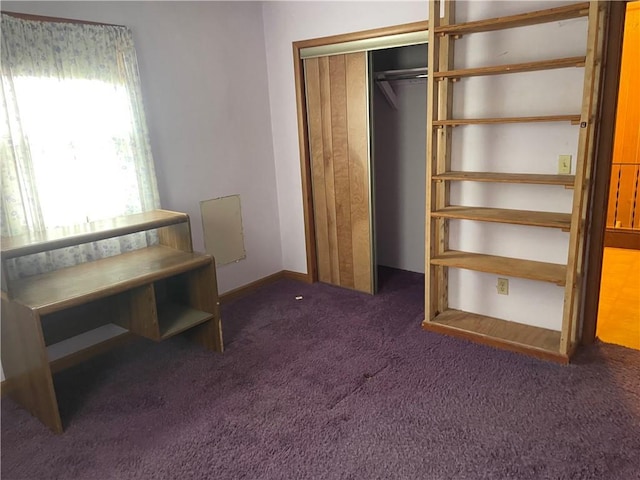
434, 2, 589, 35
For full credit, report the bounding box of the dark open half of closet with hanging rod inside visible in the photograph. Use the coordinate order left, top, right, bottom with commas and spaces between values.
369, 44, 427, 287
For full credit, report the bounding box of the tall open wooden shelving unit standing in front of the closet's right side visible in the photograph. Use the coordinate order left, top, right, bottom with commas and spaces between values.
423, 0, 608, 363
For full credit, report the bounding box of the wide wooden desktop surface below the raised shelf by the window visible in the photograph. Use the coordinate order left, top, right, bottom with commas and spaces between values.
12, 245, 212, 315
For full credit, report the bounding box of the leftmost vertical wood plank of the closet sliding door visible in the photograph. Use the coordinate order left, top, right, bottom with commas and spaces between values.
304, 58, 332, 283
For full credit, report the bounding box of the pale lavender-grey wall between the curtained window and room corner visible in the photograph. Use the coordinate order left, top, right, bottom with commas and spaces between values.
2, 1, 282, 292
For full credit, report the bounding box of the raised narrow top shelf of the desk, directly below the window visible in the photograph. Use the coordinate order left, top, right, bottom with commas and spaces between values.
1, 210, 189, 259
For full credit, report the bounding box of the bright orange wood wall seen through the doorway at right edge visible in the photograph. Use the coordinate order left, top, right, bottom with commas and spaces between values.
607, 1, 640, 230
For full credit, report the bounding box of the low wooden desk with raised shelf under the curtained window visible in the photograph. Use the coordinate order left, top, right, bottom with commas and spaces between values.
2, 210, 223, 433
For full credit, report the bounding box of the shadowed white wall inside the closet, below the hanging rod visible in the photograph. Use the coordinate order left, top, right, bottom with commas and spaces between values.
373, 80, 427, 273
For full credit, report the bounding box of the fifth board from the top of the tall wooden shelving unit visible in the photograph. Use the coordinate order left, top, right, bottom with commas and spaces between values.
431, 205, 571, 230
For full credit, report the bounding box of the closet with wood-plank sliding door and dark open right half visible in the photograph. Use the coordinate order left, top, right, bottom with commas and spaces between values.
304, 31, 427, 293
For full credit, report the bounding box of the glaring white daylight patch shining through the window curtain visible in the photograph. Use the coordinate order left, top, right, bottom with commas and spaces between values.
14, 77, 140, 227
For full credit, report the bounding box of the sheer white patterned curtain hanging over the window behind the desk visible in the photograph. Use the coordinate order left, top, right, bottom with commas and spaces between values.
0, 14, 160, 277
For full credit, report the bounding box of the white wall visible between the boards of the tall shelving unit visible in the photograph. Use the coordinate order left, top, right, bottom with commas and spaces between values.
449, 2, 587, 330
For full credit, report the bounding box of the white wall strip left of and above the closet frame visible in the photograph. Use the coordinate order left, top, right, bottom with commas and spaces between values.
262, 1, 428, 272
